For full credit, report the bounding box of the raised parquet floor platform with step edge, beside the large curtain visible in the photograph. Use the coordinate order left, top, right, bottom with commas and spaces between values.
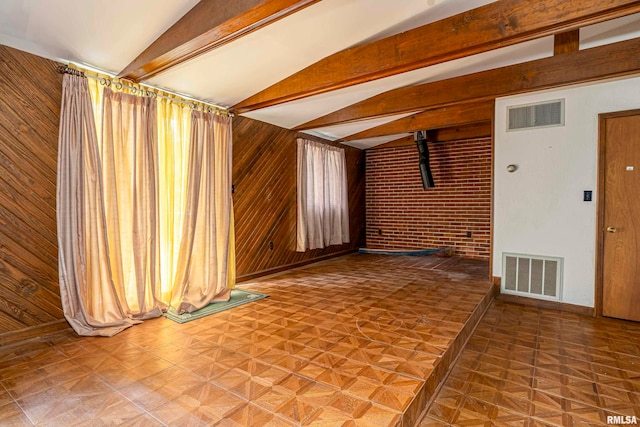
0, 254, 492, 426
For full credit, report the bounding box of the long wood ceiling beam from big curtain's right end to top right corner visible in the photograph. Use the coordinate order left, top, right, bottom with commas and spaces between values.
233, 0, 640, 113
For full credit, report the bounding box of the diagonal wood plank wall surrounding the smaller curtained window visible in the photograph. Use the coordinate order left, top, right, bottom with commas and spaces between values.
233, 117, 365, 279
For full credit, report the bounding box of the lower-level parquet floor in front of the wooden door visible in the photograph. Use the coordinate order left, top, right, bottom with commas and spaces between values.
419, 301, 640, 427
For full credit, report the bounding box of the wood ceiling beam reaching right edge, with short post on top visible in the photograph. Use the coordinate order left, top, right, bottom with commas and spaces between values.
296, 38, 640, 130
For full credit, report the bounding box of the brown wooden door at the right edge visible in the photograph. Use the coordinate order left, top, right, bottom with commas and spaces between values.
602, 114, 640, 321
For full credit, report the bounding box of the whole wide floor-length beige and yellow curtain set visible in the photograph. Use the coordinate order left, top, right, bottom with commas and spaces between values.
57, 74, 235, 336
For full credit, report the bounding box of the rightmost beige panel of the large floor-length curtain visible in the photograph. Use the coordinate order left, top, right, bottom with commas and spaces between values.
171, 111, 235, 313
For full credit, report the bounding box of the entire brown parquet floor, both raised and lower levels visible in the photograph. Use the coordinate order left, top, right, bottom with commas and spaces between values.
0, 254, 640, 426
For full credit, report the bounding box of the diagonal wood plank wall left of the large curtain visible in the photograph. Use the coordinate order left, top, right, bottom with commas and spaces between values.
0, 46, 67, 345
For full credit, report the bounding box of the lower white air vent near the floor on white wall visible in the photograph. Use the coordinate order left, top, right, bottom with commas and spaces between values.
500, 253, 563, 301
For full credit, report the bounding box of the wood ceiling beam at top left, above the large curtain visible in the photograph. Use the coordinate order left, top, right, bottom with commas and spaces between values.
118, 0, 319, 81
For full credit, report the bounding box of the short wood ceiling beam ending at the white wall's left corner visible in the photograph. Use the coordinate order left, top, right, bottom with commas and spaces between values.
341, 101, 494, 141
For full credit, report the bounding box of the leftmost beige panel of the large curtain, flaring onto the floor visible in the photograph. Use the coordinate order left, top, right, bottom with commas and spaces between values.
56, 74, 136, 336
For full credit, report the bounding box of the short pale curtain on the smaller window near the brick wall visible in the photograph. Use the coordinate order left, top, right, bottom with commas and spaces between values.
297, 138, 349, 252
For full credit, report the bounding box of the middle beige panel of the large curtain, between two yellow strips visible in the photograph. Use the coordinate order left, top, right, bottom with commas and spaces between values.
101, 88, 166, 319
